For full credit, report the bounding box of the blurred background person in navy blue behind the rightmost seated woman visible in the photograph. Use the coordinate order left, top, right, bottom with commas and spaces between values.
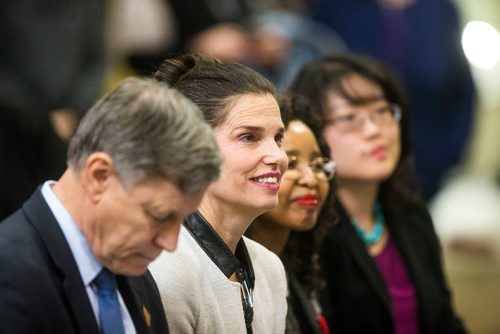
311, 0, 475, 199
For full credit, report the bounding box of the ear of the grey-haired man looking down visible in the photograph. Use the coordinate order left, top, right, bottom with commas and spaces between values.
81, 152, 115, 203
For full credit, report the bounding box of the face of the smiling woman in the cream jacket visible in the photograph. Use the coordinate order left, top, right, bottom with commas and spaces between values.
207, 94, 286, 214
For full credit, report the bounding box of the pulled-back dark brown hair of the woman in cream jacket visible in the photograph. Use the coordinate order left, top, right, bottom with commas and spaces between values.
154, 55, 276, 127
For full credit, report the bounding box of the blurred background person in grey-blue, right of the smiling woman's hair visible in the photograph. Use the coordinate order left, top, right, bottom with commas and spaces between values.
245, 4, 347, 91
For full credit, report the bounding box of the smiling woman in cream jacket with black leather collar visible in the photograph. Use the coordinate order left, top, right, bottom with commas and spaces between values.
149, 55, 287, 334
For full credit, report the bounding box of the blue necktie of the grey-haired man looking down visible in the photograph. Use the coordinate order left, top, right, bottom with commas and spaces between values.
94, 268, 125, 334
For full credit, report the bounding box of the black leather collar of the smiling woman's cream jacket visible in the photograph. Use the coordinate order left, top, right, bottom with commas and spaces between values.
184, 211, 255, 290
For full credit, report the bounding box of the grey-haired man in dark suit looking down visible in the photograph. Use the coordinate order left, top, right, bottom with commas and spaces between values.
0, 79, 221, 334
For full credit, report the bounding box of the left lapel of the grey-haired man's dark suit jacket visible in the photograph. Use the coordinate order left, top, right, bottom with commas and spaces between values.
23, 188, 99, 333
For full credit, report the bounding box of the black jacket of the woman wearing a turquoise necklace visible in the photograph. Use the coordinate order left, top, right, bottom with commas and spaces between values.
321, 196, 465, 334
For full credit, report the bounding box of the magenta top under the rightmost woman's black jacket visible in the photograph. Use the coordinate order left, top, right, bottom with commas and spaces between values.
373, 237, 418, 334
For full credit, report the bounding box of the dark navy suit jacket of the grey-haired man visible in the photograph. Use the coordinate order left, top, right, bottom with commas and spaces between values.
0, 189, 168, 334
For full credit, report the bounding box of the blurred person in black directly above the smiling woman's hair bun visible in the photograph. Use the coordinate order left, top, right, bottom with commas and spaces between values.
129, 0, 267, 74
